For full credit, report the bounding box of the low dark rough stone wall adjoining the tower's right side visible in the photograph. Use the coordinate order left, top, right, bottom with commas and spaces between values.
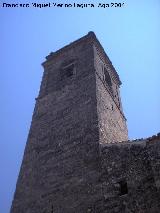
100, 137, 160, 213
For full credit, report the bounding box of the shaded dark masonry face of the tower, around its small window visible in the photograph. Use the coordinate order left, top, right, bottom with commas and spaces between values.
11, 35, 101, 213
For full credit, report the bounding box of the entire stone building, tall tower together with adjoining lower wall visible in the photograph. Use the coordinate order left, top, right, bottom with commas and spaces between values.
11, 32, 160, 213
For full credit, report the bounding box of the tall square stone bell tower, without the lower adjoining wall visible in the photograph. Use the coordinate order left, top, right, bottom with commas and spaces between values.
11, 32, 128, 213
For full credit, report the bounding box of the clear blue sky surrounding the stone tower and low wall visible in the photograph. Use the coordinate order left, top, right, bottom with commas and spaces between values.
0, 0, 160, 213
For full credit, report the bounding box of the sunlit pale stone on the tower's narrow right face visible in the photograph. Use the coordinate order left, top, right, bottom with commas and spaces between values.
94, 47, 128, 143
